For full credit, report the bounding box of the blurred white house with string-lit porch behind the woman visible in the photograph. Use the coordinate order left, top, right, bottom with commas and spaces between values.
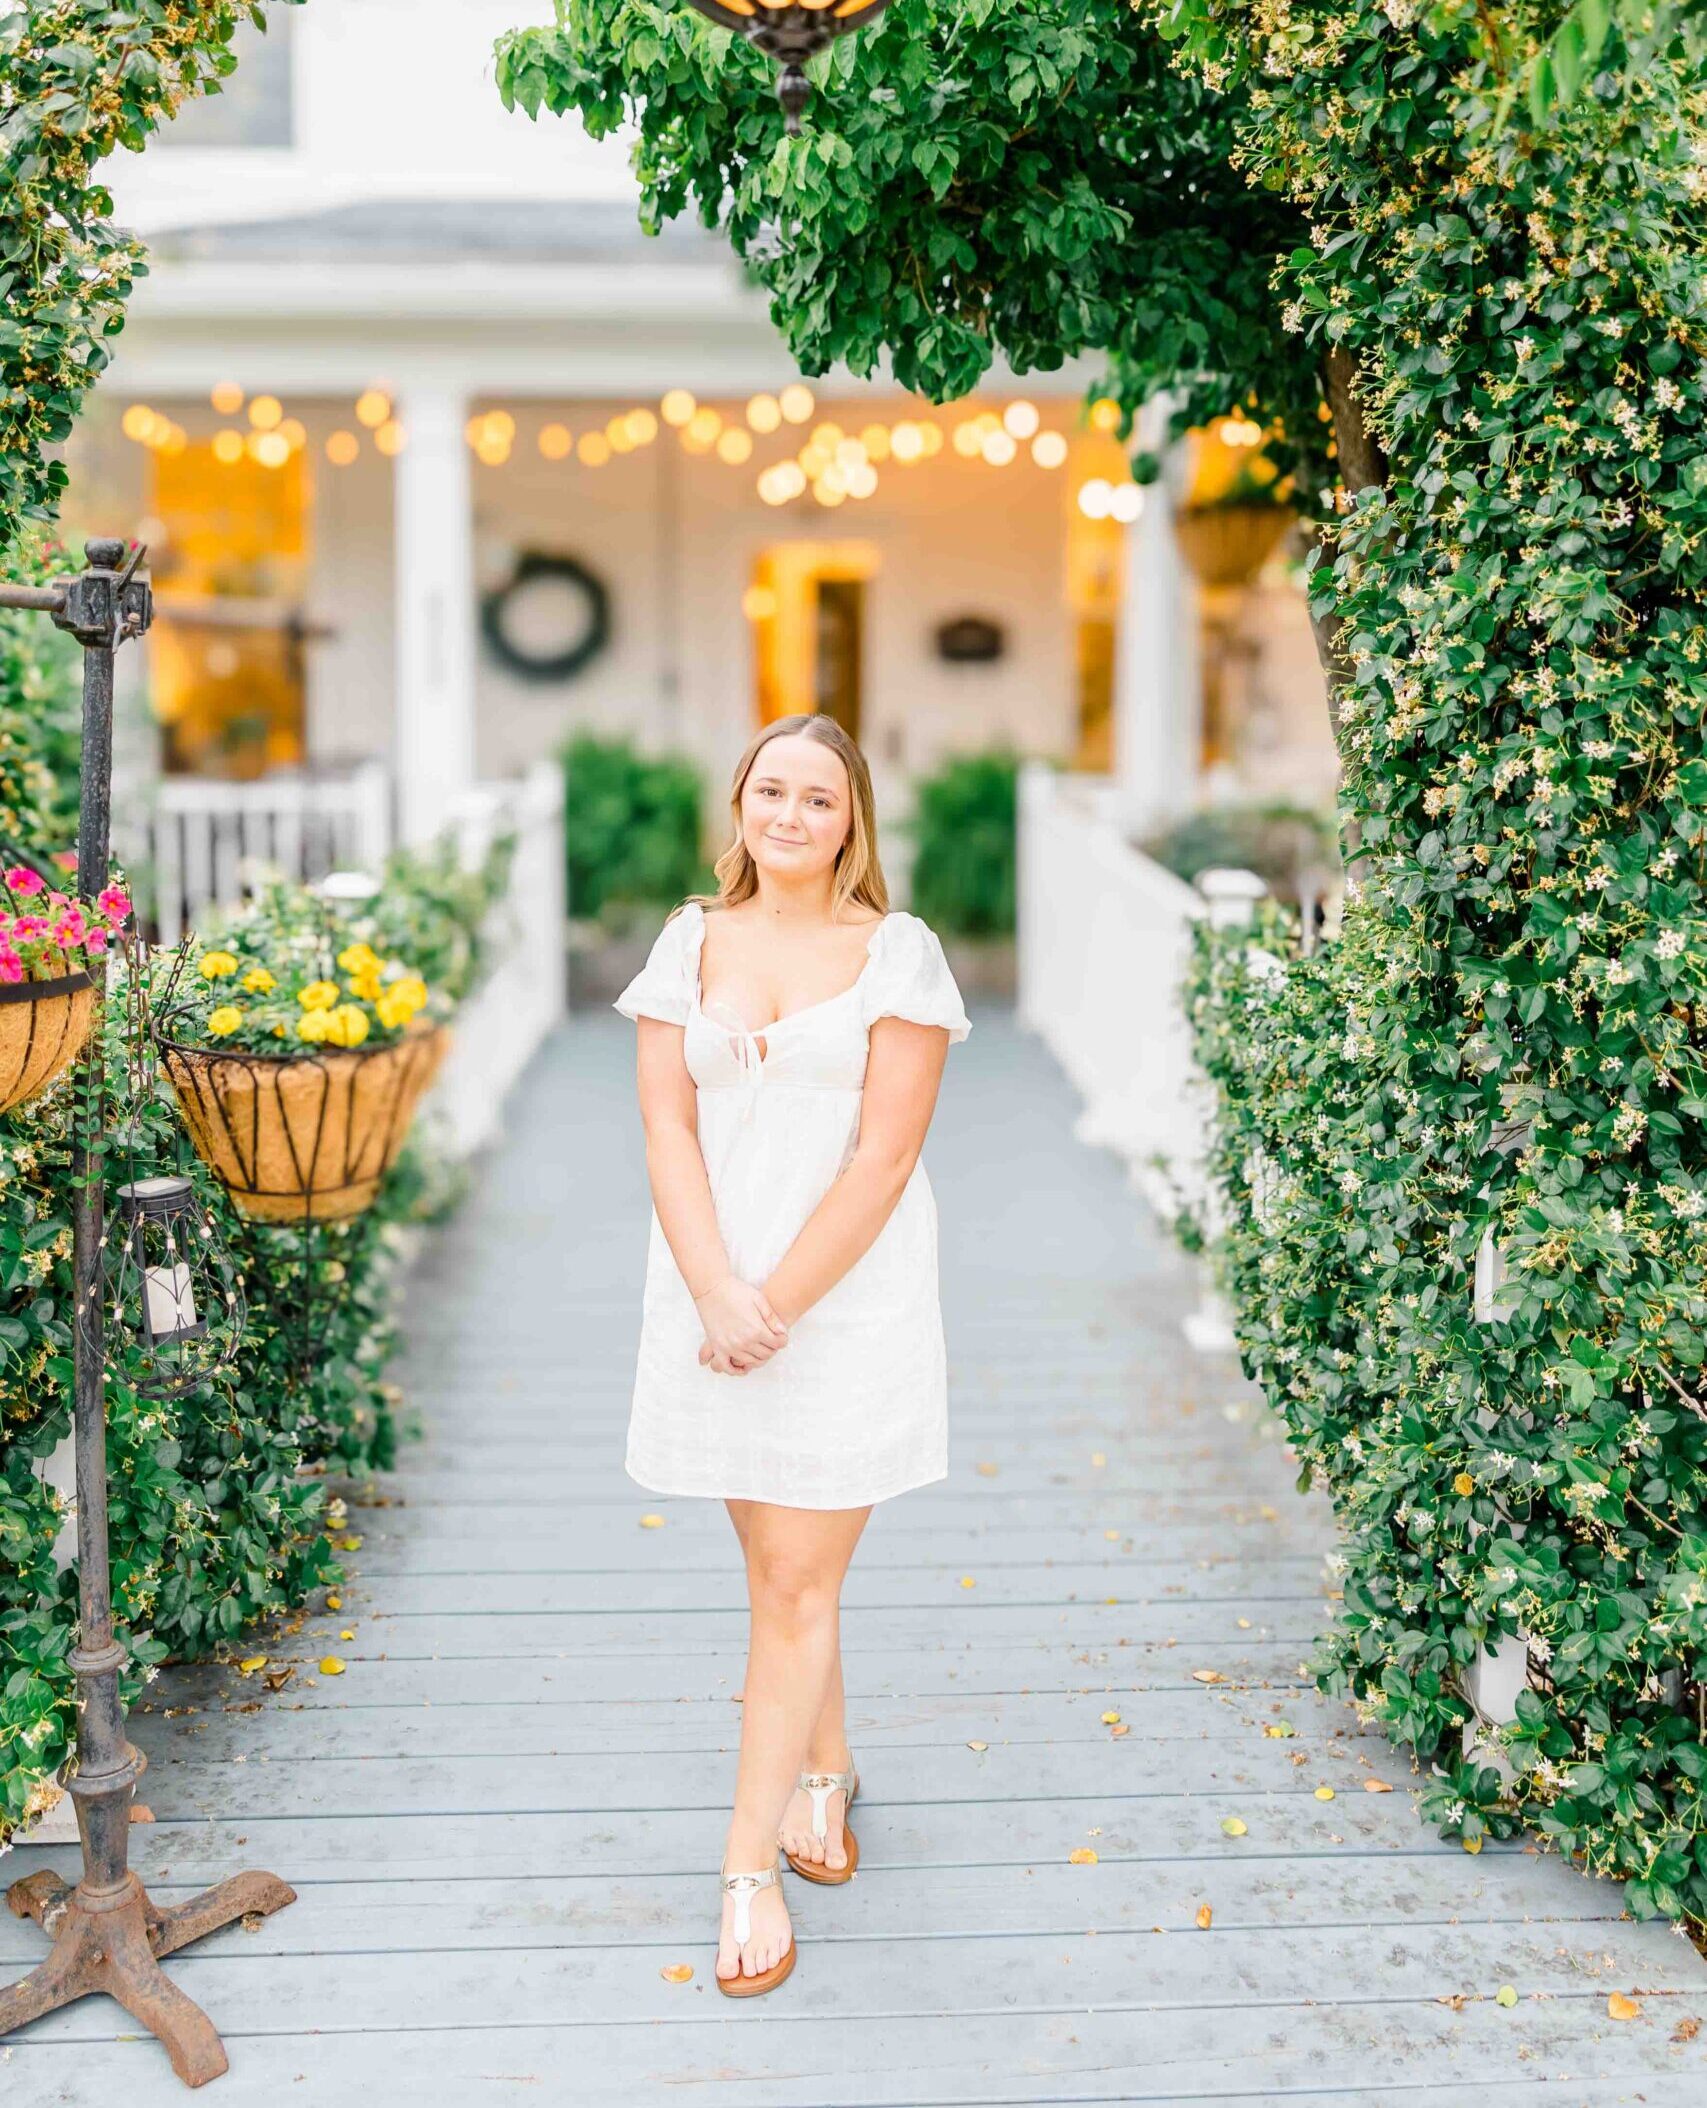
67, 0, 1332, 923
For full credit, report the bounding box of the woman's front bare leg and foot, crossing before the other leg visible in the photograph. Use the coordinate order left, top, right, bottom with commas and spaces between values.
717, 1501, 870, 1977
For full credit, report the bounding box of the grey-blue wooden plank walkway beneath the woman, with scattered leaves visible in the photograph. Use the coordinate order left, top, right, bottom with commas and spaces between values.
0, 1008, 1707, 2108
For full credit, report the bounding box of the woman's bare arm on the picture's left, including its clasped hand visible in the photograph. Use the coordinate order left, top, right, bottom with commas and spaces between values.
636, 1018, 786, 1370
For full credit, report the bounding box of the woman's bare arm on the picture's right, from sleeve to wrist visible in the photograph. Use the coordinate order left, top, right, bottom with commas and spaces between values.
765, 1018, 948, 1326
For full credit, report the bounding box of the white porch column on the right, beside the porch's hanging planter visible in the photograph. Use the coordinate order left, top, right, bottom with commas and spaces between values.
1115, 398, 1203, 835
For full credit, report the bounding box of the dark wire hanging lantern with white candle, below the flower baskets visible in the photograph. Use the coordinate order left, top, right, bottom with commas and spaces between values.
105, 1172, 244, 1398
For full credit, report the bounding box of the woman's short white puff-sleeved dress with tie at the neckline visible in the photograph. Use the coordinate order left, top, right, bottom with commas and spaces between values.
615, 902, 972, 1507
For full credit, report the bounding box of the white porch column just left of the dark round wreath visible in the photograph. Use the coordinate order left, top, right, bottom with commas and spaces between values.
392, 384, 474, 841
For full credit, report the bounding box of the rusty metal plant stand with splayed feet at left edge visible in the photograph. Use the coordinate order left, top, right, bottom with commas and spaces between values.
0, 540, 295, 2087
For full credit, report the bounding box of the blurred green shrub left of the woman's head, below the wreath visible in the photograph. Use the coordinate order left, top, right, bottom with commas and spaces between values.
563, 734, 717, 917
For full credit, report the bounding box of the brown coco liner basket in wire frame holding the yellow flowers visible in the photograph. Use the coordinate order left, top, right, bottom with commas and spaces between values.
156, 1024, 451, 1223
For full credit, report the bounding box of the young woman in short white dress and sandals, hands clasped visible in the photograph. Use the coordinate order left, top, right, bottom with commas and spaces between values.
615, 717, 972, 1998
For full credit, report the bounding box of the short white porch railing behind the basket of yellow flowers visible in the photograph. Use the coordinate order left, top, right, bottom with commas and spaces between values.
148, 761, 392, 944
